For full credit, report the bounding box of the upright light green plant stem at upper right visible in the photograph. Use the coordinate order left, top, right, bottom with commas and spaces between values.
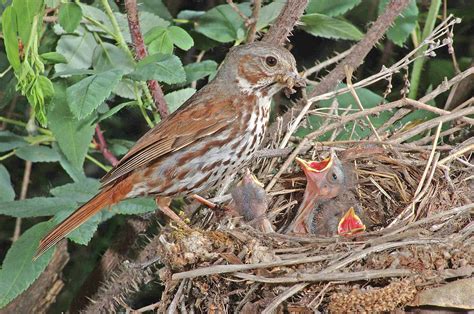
408, 0, 441, 99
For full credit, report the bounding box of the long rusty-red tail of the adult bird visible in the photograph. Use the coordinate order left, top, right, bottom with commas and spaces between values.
33, 178, 132, 259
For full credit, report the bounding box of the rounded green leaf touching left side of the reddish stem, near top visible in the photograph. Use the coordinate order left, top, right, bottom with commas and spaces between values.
92, 43, 135, 73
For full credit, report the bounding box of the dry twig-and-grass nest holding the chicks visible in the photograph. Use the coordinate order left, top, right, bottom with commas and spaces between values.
149, 146, 474, 313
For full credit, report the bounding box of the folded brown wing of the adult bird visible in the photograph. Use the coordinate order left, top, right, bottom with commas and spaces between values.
101, 88, 238, 186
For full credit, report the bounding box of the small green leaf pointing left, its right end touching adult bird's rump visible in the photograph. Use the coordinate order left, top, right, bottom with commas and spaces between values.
49, 178, 100, 203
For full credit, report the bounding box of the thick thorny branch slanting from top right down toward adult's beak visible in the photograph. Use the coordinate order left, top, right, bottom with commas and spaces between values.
264, 0, 409, 144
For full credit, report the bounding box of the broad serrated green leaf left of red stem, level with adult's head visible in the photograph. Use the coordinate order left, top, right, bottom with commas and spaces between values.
66, 69, 123, 119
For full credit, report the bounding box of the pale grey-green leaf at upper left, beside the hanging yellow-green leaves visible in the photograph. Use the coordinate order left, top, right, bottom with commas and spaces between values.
54, 26, 97, 72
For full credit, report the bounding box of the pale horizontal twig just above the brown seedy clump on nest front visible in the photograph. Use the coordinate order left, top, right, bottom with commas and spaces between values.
234, 269, 413, 284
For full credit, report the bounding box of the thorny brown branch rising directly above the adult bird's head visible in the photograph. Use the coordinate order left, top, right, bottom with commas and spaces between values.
262, 0, 308, 45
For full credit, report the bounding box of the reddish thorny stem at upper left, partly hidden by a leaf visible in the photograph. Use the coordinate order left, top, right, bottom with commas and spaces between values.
125, 0, 169, 119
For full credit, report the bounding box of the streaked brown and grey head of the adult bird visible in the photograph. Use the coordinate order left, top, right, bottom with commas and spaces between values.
216, 42, 305, 96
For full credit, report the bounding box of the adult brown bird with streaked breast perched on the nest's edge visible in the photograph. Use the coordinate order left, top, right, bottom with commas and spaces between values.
36, 42, 304, 256
